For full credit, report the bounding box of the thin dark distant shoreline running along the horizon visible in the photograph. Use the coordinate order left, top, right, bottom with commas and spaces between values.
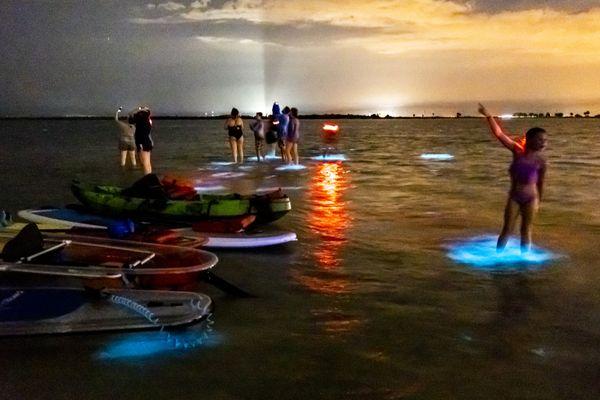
0, 113, 600, 121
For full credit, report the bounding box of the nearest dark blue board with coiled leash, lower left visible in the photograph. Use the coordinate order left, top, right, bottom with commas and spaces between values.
0, 287, 213, 336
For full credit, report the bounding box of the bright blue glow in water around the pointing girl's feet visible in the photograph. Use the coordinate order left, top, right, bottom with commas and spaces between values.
448, 235, 560, 272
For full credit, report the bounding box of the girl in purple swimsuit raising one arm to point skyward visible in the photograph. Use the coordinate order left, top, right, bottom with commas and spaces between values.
478, 104, 547, 252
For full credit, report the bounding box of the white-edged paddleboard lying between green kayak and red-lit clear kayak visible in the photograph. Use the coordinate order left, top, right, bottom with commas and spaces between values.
18, 208, 298, 249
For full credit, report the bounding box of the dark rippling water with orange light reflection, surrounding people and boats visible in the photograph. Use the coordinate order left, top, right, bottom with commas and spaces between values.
0, 119, 600, 399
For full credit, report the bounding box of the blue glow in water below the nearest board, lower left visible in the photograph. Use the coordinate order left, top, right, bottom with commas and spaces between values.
96, 330, 221, 360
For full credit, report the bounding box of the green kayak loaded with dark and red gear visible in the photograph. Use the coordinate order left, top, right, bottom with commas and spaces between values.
71, 175, 292, 224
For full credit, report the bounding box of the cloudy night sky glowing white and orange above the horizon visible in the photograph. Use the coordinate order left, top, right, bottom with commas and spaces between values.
0, 0, 600, 116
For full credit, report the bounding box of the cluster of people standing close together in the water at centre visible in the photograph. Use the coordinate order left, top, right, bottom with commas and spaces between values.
225, 102, 300, 164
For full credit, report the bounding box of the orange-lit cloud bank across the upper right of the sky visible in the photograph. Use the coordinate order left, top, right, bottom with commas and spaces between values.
133, 0, 600, 63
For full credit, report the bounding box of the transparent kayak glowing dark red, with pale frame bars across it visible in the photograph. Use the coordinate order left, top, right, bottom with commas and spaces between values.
0, 224, 218, 288
